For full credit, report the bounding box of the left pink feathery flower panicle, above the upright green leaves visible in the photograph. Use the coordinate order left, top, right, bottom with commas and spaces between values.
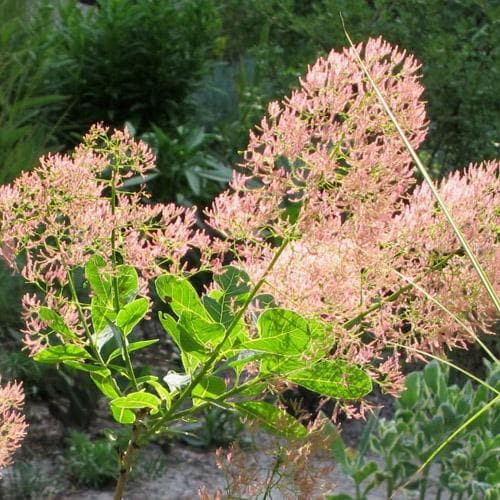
0, 125, 208, 355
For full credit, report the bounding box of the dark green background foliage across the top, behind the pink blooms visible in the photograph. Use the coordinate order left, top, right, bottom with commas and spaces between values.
0, 0, 500, 484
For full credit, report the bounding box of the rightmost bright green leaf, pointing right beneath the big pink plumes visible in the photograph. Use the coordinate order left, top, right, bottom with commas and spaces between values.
285, 360, 372, 399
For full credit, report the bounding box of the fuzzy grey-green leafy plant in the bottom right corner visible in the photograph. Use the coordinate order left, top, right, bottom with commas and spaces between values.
331, 360, 500, 500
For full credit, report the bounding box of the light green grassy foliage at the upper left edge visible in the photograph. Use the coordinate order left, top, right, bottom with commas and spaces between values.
0, 0, 64, 184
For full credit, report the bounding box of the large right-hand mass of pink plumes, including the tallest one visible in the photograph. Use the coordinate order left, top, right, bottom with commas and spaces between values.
207, 39, 500, 394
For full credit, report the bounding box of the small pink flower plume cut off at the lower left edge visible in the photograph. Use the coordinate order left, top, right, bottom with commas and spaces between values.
0, 380, 28, 475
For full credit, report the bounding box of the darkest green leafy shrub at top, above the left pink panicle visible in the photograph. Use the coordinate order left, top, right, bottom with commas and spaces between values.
46, 0, 219, 142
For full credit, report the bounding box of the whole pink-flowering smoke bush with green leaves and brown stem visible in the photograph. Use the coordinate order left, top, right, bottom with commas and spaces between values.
0, 39, 500, 499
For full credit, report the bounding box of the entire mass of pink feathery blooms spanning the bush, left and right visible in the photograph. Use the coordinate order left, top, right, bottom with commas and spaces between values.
0, 39, 500, 406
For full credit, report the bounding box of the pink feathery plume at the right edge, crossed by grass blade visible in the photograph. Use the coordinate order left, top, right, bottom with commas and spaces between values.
378, 161, 500, 353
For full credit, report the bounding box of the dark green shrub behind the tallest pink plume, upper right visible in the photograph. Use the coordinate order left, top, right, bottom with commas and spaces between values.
214, 0, 500, 174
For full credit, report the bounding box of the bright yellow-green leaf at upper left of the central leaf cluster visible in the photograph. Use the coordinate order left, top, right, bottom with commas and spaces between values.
155, 274, 210, 320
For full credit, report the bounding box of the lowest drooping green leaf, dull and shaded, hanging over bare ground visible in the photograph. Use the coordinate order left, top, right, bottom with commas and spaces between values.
233, 401, 307, 438
